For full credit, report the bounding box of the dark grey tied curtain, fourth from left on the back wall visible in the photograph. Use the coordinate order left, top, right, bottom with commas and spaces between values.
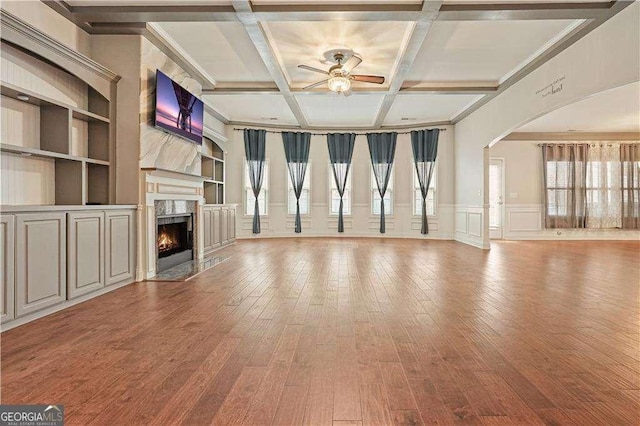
367, 132, 398, 234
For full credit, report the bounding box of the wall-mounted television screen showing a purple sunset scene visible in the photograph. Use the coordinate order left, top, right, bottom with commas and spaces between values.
156, 70, 204, 144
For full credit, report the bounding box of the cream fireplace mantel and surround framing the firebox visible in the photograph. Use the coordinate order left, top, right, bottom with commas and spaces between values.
138, 169, 204, 280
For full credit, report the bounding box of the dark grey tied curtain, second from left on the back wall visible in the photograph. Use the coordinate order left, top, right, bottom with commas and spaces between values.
282, 132, 311, 233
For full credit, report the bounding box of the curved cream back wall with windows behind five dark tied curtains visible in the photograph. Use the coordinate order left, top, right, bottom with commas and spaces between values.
226, 126, 454, 239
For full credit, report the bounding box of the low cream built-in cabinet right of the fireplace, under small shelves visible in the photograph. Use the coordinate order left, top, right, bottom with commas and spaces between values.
202, 204, 236, 254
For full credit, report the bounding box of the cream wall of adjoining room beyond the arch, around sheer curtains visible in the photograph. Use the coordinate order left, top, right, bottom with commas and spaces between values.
489, 138, 640, 240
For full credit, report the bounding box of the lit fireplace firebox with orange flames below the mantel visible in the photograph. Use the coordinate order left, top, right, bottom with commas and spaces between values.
156, 214, 193, 272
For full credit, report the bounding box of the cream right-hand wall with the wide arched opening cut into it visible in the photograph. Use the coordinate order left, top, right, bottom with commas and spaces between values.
455, 3, 640, 248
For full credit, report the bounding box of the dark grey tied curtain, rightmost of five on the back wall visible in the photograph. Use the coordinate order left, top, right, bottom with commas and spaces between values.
411, 129, 440, 235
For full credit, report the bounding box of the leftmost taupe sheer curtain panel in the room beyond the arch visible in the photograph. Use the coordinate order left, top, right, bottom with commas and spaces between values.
542, 144, 589, 229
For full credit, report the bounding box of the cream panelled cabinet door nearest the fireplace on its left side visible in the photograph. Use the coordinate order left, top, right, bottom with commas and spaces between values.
105, 210, 136, 285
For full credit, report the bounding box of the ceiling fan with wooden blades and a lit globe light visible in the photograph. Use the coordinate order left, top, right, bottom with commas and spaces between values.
298, 52, 384, 96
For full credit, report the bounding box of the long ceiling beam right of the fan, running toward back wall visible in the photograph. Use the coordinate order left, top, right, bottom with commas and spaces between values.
373, 1, 442, 127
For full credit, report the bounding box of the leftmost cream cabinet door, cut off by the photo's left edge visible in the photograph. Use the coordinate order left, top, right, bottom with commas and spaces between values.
0, 215, 16, 322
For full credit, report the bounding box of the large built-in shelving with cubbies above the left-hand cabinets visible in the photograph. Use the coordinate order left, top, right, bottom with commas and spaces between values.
0, 81, 111, 205
